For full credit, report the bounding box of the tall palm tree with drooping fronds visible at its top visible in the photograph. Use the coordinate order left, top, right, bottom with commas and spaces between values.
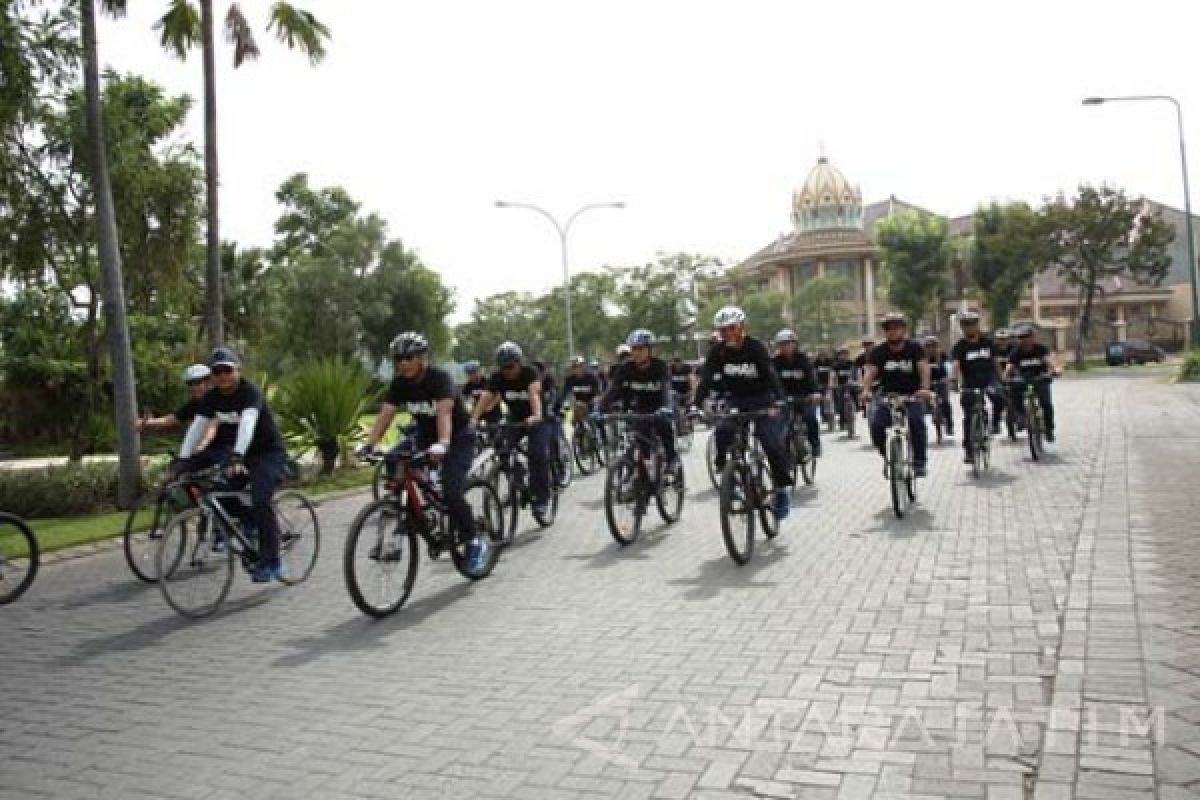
155, 0, 329, 347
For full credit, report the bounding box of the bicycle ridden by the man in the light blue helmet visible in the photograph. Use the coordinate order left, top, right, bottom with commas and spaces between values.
604, 413, 686, 547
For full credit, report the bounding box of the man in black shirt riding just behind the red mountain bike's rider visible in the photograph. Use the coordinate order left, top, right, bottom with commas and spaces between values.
470, 342, 551, 517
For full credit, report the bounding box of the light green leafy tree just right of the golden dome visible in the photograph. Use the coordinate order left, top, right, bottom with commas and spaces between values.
875, 212, 950, 327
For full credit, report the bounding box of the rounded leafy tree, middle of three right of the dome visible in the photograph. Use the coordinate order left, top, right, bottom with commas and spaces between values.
967, 203, 1046, 327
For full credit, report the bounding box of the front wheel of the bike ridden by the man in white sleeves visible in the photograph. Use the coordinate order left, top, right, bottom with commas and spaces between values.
157, 509, 234, 619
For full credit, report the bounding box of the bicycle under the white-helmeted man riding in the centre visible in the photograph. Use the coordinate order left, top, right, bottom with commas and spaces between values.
720, 409, 779, 566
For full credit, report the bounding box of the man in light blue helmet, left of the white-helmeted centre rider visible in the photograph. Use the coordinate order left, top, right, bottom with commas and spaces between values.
596, 327, 678, 471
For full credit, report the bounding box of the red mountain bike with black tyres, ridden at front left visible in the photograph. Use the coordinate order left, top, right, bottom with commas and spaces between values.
342, 439, 504, 619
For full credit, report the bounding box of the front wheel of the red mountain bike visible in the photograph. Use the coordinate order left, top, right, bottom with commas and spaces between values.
342, 498, 420, 618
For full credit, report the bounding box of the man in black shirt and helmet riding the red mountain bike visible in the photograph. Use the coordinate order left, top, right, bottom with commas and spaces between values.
359, 331, 491, 571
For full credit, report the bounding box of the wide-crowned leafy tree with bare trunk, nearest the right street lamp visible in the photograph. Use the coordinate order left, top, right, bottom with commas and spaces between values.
1043, 185, 1175, 367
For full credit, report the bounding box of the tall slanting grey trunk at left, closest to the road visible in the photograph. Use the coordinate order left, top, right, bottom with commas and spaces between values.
83, 0, 142, 509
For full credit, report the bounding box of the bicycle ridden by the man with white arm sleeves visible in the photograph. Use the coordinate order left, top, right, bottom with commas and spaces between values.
156, 467, 320, 619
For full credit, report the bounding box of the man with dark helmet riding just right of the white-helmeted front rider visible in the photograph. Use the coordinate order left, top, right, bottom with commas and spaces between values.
863, 312, 934, 477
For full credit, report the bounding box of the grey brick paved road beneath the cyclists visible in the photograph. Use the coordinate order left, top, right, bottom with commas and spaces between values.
0, 377, 1200, 800
